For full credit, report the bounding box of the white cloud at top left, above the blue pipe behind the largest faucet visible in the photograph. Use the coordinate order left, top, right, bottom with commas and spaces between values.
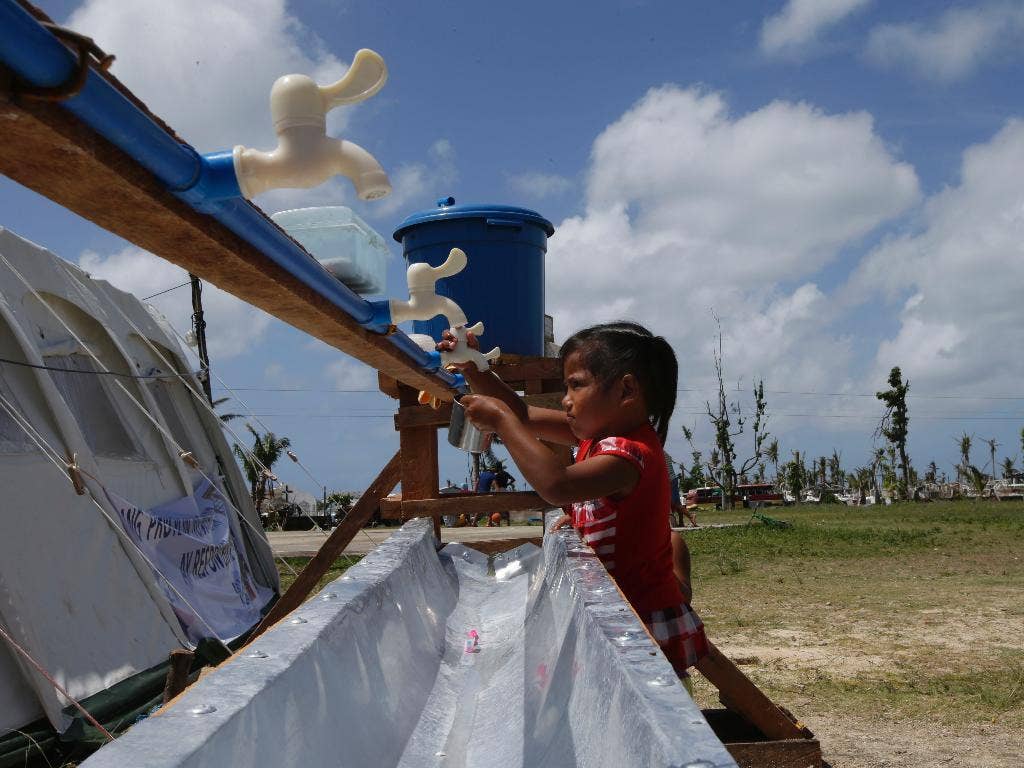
68, 0, 357, 152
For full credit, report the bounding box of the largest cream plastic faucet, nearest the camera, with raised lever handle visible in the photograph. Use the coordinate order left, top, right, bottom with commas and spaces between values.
232, 48, 391, 200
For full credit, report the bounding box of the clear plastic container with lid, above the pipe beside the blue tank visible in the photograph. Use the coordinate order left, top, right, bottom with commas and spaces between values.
270, 206, 391, 295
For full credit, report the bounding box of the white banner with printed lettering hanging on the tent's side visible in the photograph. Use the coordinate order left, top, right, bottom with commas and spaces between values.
106, 479, 272, 642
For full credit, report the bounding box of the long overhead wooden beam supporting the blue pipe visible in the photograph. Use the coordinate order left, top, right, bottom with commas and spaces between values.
0, 92, 452, 400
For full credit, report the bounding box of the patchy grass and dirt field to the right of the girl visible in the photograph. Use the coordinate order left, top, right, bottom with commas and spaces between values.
691, 509, 1024, 768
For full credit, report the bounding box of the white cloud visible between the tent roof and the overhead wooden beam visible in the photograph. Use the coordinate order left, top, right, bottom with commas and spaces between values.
79, 246, 270, 358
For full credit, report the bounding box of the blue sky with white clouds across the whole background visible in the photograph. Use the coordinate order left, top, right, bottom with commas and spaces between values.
0, 0, 1024, 490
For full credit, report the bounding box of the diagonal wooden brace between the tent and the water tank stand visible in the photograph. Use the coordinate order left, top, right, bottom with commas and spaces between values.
246, 454, 401, 645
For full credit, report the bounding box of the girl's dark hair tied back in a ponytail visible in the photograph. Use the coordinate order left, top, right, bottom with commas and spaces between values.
559, 322, 679, 445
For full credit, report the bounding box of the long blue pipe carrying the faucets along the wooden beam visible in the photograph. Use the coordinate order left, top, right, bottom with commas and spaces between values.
0, 0, 458, 387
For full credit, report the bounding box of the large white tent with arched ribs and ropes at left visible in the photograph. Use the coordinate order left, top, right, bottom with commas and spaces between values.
0, 228, 279, 736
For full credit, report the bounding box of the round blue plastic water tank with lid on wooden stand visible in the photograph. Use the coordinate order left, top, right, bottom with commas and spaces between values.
394, 198, 555, 356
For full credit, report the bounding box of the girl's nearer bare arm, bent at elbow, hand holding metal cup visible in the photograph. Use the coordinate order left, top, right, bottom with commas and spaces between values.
462, 395, 640, 507
